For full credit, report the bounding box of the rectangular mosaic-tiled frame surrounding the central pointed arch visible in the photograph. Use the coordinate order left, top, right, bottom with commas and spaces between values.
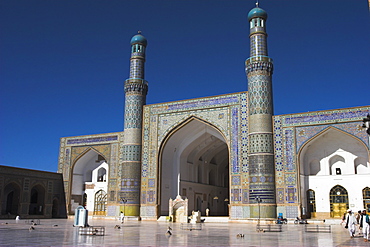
141, 92, 248, 216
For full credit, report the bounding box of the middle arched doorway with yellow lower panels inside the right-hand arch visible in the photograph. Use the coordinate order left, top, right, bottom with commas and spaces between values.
329, 185, 348, 218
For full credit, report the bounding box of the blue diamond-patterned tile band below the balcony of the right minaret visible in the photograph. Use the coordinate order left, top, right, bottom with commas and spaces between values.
248, 71, 273, 115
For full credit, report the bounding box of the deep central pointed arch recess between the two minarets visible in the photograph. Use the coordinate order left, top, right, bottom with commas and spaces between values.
158, 117, 229, 215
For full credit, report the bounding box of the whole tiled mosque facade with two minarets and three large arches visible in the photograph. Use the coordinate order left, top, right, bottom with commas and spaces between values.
58, 6, 370, 220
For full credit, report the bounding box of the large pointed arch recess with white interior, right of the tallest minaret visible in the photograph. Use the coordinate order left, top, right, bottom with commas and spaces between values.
297, 127, 370, 218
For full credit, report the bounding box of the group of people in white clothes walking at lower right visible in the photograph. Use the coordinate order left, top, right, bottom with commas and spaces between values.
343, 209, 370, 242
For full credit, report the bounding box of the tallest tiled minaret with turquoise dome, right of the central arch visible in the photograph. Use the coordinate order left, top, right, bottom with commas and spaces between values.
245, 3, 276, 218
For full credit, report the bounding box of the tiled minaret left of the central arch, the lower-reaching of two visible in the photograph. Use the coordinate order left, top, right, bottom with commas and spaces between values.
120, 32, 148, 216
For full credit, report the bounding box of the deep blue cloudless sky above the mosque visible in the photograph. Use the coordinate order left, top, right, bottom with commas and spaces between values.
0, 0, 370, 171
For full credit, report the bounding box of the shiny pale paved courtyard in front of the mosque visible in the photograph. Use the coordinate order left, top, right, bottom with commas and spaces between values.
0, 219, 370, 247
